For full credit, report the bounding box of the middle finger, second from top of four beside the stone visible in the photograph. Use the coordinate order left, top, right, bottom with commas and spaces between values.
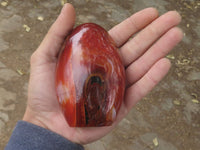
120, 11, 181, 66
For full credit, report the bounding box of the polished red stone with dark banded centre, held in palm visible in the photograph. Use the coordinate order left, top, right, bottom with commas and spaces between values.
56, 23, 125, 127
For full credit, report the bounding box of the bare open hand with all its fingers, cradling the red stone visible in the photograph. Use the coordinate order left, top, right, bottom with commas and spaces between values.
23, 4, 183, 144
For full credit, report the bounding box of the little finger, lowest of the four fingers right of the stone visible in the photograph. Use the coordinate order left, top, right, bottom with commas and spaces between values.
125, 58, 171, 111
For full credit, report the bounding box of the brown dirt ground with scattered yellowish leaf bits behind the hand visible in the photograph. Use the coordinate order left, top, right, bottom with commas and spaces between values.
0, 0, 200, 150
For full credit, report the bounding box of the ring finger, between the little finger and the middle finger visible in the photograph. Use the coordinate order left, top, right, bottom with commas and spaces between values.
126, 27, 183, 84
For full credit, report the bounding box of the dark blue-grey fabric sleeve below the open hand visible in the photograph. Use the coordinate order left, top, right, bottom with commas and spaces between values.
5, 121, 84, 150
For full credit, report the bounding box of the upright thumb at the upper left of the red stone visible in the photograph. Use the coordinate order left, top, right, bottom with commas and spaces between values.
34, 3, 75, 57
